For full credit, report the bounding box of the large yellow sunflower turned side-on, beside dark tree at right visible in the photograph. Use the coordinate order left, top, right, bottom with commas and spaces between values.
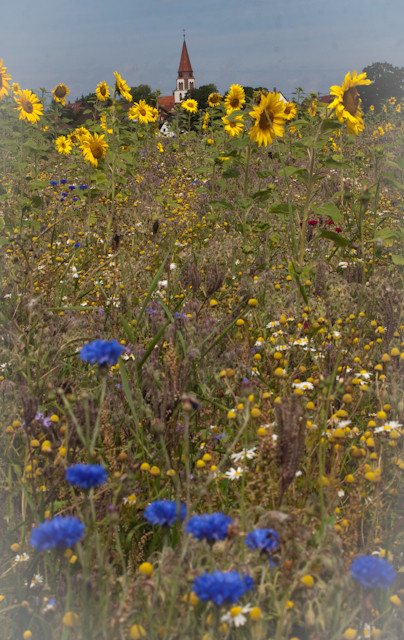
329, 70, 372, 135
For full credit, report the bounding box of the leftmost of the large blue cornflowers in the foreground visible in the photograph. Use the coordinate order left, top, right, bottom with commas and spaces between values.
30, 516, 84, 551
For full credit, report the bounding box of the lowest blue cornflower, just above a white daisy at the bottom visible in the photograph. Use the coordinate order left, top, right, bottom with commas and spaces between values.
193, 570, 254, 605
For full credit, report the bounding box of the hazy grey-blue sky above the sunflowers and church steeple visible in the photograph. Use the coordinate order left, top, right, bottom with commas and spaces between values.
0, 0, 404, 100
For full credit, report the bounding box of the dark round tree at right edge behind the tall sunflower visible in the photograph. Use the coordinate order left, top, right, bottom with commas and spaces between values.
359, 62, 404, 111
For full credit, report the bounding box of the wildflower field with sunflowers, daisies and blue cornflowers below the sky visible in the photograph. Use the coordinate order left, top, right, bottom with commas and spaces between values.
0, 61, 404, 640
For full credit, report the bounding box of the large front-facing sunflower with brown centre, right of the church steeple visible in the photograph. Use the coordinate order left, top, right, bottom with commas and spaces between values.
249, 93, 286, 147
